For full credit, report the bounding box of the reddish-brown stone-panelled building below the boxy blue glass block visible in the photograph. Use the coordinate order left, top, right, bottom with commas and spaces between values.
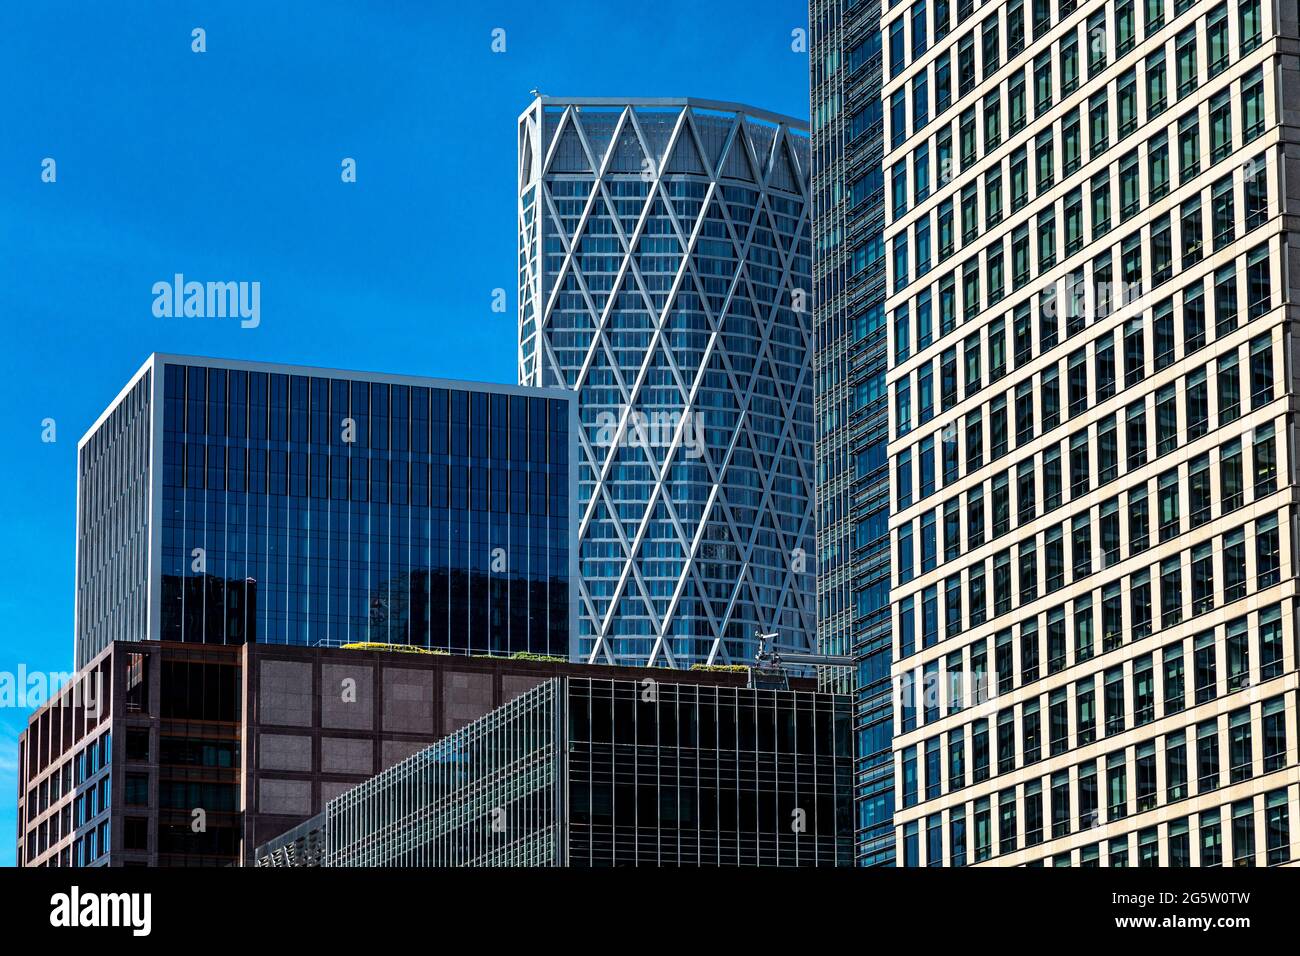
17, 641, 759, 866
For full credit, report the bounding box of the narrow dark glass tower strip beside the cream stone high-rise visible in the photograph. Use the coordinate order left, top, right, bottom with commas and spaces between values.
809, 0, 899, 866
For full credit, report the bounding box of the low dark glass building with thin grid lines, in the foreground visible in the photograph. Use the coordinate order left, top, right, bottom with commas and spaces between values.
324, 678, 853, 866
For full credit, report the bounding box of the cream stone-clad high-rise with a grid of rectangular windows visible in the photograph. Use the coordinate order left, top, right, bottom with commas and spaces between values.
880, 0, 1300, 866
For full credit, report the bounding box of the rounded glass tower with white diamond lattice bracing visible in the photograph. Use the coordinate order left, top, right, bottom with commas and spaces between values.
519, 96, 815, 667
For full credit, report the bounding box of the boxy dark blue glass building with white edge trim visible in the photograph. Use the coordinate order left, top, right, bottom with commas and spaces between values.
75, 355, 577, 667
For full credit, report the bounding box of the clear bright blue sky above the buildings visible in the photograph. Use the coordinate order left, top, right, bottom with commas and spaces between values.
0, 0, 809, 865
